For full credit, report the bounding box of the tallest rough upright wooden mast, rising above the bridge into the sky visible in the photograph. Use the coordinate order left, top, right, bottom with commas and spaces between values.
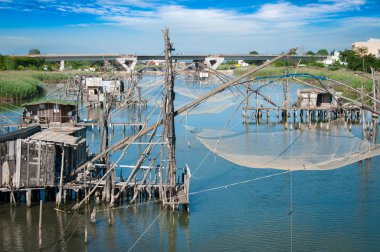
163, 28, 177, 208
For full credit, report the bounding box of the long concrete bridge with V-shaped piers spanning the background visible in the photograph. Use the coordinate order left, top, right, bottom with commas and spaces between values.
15, 54, 327, 72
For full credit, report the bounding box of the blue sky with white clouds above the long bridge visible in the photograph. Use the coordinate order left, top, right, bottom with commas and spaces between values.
0, 0, 380, 54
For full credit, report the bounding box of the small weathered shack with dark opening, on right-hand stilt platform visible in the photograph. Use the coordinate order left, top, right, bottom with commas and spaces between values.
297, 89, 339, 109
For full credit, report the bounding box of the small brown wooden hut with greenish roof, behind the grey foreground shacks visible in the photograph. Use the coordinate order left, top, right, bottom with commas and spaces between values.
22, 100, 77, 124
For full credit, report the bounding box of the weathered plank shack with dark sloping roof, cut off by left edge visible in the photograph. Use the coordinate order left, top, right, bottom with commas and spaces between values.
0, 126, 41, 188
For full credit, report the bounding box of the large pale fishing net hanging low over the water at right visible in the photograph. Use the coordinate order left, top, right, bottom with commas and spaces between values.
187, 127, 380, 170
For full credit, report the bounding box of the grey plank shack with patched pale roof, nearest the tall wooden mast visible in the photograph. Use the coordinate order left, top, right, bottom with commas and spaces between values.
19, 127, 87, 187
